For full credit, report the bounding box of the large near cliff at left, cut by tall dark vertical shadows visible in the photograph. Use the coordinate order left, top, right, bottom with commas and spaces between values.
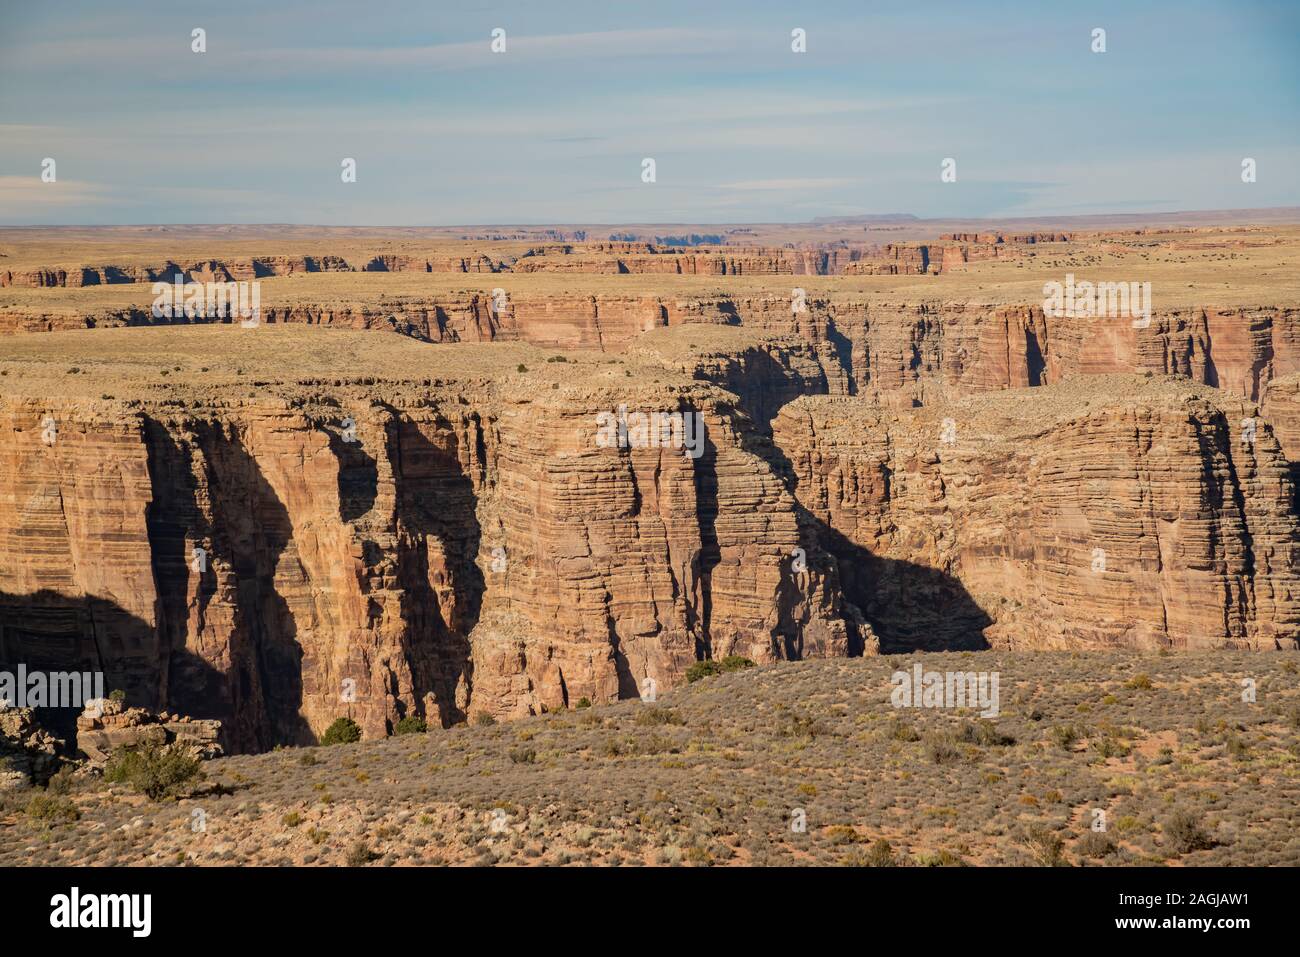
0, 330, 861, 750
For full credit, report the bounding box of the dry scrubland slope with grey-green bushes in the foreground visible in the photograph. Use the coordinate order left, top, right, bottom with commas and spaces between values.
0, 651, 1300, 866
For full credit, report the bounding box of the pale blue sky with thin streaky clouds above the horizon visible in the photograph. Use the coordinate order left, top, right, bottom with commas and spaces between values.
0, 0, 1300, 225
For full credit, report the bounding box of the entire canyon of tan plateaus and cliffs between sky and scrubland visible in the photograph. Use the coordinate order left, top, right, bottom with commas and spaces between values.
0, 225, 1300, 752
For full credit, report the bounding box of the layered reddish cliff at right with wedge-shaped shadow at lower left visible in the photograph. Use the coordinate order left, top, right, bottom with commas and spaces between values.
774, 377, 1300, 650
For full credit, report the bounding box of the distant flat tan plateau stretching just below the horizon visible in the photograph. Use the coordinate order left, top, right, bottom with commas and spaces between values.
0, 226, 1300, 308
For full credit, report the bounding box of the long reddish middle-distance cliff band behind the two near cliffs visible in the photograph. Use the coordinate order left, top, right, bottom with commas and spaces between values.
0, 291, 1300, 416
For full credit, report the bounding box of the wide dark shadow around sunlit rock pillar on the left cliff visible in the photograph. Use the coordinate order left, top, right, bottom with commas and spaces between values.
144, 419, 315, 752
